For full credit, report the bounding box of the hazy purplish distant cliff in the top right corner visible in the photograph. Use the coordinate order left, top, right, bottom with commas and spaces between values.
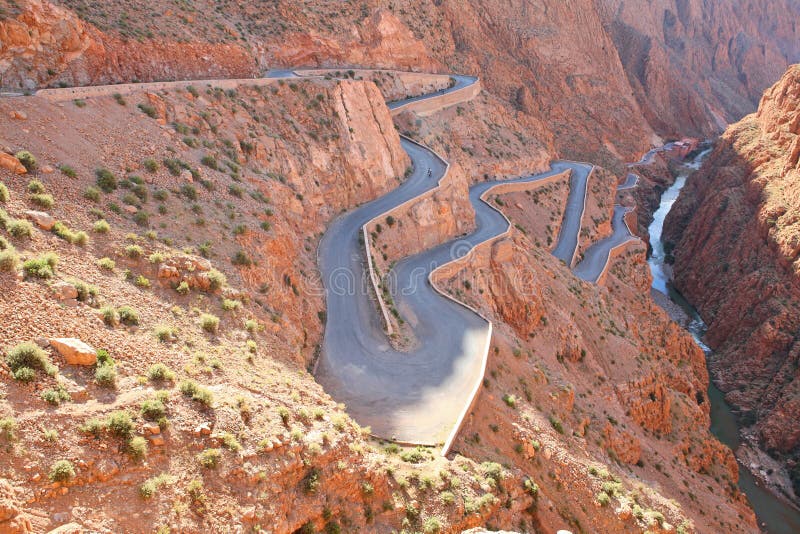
595, 0, 800, 137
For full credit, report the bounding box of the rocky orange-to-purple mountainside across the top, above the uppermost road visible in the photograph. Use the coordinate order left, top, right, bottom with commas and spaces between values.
0, 0, 800, 167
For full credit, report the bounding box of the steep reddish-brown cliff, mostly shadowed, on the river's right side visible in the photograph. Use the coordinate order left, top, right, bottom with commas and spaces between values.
665, 67, 800, 502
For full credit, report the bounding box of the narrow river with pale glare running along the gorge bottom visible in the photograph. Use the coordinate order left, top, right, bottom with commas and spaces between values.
648, 150, 800, 534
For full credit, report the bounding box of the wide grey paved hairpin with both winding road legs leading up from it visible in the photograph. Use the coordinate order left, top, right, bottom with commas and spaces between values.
317, 157, 580, 444
